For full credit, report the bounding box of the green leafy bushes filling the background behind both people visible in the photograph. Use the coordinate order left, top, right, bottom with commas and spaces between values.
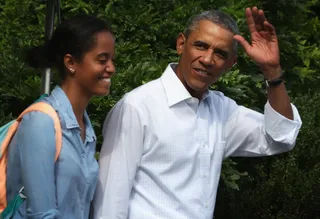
0, 0, 320, 219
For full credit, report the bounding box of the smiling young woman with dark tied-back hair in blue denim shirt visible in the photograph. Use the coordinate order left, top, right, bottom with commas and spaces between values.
7, 16, 115, 219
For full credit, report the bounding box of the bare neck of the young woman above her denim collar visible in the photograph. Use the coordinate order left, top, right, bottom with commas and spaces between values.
61, 81, 91, 125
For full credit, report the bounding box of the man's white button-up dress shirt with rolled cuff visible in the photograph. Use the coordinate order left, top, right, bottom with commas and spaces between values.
94, 64, 301, 219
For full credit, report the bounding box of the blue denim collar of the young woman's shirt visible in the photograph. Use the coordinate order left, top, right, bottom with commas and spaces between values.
51, 86, 97, 140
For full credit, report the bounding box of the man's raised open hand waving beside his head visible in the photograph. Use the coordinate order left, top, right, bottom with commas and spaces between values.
234, 7, 281, 78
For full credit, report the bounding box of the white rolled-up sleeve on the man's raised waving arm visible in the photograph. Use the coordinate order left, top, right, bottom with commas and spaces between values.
224, 100, 302, 157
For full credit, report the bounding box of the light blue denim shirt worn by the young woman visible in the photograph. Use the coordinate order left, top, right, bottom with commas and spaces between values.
7, 87, 98, 219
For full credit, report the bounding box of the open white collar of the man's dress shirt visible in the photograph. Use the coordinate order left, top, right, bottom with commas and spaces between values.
160, 63, 209, 107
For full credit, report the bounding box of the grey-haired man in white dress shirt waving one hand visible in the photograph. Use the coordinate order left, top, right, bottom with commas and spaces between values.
94, 7, 301, 219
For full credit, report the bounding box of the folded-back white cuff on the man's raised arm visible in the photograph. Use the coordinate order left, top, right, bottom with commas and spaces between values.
264, 101, 302, 145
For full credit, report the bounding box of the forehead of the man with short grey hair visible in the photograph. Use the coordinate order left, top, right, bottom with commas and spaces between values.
188, 20, 234, 49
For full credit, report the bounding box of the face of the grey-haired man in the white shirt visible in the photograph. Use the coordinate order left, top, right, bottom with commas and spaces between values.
176, 20, 236, 98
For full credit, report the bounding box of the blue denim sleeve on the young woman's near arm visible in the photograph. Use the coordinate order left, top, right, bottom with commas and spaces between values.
16, 112, 59, 219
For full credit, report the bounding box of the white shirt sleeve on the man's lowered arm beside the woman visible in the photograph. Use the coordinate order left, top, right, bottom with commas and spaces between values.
94, 100, 144, 219
